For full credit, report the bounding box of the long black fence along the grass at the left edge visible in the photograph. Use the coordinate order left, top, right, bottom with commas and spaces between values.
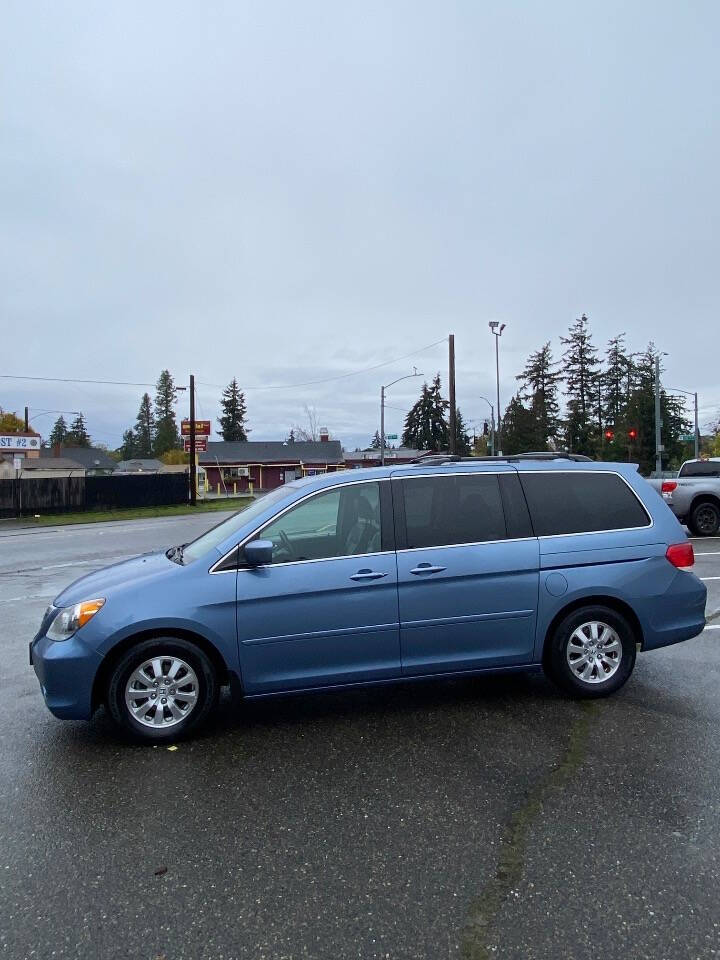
0, 473, 189, 517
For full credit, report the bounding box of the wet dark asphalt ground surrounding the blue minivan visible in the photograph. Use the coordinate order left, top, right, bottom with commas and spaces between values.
0, 515, 720, 960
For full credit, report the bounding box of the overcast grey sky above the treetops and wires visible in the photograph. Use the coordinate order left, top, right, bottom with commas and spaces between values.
0, 0, 720, 447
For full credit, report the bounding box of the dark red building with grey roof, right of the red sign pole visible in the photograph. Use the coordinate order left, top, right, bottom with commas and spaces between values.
199, 439, 345, 494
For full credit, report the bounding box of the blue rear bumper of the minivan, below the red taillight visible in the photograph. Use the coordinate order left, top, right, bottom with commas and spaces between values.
642, 570, 707, 650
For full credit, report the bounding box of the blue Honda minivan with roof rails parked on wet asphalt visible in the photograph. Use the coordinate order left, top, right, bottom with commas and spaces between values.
30, 454, 706, 742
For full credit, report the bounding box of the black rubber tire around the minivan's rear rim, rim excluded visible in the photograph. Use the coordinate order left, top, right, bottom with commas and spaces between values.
543, 605, 636, 698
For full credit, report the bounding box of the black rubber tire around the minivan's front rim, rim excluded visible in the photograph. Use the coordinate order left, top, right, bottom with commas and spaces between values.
107, 637, 219, 743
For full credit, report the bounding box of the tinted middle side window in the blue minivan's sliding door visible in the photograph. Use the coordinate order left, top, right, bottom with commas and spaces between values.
402, 474, 506, 549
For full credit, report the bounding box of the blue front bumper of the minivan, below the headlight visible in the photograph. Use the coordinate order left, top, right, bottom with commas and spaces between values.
30, 633, 102, 720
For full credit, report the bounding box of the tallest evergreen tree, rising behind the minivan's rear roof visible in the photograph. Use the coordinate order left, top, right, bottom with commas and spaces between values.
560, 314, 599, 456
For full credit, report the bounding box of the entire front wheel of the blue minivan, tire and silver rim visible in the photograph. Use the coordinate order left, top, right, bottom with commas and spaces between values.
107, 637, 218, 743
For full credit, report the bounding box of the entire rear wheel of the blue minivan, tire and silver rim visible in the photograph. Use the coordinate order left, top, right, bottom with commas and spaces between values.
544, 606, 636, 697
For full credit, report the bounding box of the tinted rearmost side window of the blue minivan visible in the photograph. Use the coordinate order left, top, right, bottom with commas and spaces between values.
520, 470, 650, 537
